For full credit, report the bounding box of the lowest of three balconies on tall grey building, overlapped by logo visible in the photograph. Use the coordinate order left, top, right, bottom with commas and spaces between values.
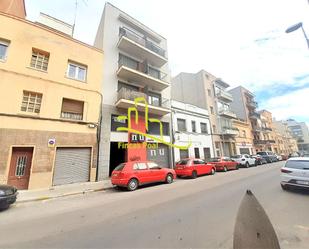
115, 87, 171, 116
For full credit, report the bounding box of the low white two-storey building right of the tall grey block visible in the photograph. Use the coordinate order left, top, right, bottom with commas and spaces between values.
171, 100, 214, 162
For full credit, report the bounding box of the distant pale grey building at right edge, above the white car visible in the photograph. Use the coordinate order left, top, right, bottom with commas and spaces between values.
283, 119, 309, 153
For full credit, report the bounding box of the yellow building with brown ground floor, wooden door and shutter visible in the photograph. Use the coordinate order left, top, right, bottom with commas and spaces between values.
0, 6, 103, 189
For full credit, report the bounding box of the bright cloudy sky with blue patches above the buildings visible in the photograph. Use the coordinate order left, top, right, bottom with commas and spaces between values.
26, 0, 309, 125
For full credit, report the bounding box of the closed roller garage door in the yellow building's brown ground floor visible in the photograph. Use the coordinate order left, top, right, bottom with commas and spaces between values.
53, 148, 91, 186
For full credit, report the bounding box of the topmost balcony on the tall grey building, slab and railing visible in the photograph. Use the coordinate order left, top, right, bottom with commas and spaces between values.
118, 27, 167, 67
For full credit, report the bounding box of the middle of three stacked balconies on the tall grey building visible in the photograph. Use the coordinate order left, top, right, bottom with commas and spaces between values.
117, 56, 170, 91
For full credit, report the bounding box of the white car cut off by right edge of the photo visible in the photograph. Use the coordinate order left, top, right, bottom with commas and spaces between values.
281, 157, 309, 190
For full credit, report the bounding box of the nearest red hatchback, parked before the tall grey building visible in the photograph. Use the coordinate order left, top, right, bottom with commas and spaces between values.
111, 161, 176, 191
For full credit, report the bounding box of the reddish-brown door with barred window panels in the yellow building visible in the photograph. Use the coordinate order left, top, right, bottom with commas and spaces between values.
8, 147, 33, 189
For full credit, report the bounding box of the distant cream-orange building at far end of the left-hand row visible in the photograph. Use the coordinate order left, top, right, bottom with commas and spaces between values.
273, 120, 298, 155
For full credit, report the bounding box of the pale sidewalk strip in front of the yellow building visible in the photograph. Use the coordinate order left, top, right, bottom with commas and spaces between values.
16, 179, 113, 203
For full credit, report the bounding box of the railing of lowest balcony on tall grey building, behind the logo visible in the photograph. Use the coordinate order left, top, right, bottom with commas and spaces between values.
117, 87, 171, 109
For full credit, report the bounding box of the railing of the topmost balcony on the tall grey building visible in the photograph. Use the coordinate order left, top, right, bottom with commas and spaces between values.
119, 27, 166, 58
